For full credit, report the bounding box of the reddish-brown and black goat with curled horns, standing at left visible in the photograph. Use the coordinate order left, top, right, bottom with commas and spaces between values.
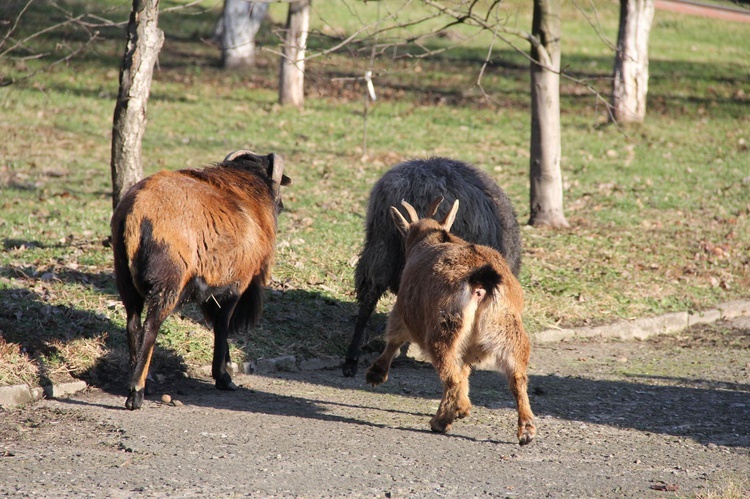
112, 151, 291, 410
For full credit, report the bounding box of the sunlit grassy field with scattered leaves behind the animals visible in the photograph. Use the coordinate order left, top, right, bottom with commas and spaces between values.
0, 1, 750, 385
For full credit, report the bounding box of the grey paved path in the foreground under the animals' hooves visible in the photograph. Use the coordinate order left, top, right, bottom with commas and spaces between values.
0, 318, 750, 497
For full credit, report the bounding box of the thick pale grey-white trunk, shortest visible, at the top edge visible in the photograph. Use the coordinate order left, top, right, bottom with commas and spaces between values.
217, 0, 269, 69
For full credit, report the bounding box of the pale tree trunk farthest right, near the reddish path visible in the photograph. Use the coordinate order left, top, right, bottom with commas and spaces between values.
610, 0, 654, 123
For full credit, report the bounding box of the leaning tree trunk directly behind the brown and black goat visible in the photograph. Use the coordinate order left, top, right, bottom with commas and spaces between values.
111, 0, 164, 207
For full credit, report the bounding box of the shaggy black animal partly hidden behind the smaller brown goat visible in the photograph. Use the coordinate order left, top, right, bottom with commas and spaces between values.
343, 158, 521, 376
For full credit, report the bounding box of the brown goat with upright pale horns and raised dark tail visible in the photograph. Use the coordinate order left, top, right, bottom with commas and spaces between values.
366, 197, 536, 445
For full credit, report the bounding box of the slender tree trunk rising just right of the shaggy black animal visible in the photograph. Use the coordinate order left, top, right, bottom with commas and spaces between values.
529, 0, 569, 227
